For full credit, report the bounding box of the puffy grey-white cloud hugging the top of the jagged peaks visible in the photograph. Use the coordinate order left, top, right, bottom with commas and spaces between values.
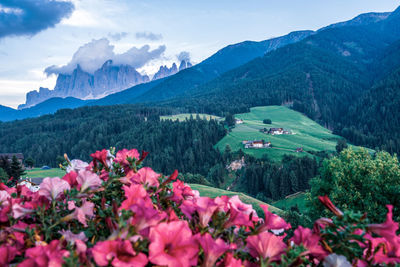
45, 38, 165, 75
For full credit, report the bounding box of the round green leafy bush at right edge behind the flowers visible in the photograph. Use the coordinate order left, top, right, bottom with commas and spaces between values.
308, 149, 400, 221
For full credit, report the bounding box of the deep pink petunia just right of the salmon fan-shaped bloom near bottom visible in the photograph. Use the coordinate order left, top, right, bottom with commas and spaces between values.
290, 226, 327, 259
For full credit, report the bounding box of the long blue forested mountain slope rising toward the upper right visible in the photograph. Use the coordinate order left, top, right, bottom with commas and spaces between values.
0, 5, 400, 131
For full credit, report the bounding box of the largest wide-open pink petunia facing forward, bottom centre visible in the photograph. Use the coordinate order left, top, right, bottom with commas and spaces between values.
149, 221, 199, 267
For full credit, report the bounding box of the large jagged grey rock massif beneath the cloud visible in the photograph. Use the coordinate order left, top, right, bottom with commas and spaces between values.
18, 60, 150, 109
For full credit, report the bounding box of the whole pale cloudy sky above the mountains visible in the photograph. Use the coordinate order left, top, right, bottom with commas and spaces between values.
0, 0, 400, 107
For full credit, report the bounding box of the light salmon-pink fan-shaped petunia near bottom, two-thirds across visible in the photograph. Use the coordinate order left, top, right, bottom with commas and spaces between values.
246, 232, 286, 261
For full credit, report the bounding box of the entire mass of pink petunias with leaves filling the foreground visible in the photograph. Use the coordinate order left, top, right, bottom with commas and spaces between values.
0, 149, 400, 266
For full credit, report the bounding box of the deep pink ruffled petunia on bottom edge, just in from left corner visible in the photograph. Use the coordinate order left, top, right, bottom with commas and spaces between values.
18, 240, 69, 267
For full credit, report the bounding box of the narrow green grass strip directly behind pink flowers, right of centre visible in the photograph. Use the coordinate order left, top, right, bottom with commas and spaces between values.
190, 184, 285, 216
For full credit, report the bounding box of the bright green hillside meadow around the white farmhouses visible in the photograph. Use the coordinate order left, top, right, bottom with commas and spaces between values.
216, 106, 346, 159
